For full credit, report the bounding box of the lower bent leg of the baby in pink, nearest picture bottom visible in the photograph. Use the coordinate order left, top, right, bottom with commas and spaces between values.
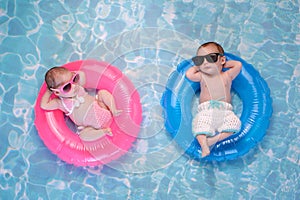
79, 126, 112, 141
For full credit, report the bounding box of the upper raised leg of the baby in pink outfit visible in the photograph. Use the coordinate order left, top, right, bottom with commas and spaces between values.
98, 90, 121, 115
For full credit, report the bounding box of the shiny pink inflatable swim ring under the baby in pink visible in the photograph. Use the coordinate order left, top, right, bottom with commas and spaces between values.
34, 60, 142, 166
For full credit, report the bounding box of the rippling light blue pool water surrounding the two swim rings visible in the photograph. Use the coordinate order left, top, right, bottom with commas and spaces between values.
0, 0, 300, 199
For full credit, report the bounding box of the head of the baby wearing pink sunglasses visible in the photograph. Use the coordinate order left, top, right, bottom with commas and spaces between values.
45, 67, 79, 97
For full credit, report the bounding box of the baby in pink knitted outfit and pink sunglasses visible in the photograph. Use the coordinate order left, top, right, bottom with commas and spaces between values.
41, 67, 121, 141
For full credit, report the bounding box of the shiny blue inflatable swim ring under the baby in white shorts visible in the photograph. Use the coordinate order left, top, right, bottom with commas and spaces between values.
161, 53, 272, 161
